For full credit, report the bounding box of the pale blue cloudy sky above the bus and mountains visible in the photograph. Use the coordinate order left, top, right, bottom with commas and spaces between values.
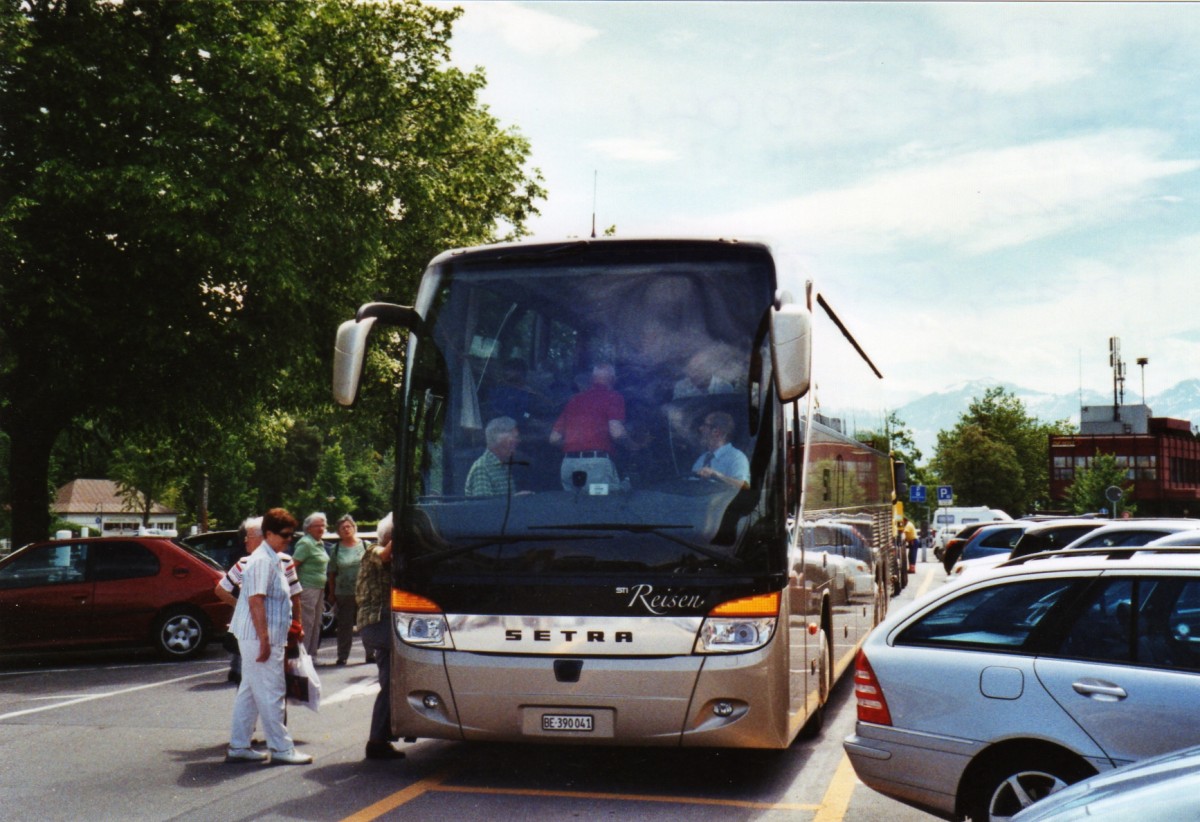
437, 0, 1200, 402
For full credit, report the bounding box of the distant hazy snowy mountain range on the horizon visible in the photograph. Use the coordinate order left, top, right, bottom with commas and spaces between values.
895, 379, 1200, 463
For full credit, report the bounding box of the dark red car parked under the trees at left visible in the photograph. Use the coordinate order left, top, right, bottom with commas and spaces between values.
0, 536, 233, 660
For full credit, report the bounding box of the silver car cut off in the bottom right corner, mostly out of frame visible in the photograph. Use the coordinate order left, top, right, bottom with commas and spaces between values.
1015, 746, 1200, 822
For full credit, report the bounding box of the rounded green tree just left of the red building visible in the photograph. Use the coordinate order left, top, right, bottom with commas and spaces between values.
931, 386, 1070, 515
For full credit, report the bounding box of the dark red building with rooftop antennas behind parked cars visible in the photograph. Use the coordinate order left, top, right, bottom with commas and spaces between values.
1050, 406, 1200, 516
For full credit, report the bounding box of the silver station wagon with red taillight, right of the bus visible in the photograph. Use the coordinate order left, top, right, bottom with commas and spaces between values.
845, 547, 1200, 820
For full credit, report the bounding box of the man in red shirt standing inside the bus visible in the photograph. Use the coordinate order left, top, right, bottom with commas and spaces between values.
550, 364, 626, 491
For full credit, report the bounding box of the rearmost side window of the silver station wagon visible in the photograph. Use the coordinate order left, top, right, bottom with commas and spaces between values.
896, 578, 1075, 650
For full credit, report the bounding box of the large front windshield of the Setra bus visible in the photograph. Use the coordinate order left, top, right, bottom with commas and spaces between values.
401, 242, 786, 577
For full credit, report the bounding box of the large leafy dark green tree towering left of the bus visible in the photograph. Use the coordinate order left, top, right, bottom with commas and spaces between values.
0, 0, 544, 544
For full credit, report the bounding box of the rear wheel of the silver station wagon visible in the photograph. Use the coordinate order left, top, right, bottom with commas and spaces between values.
967, 751, 1094, 822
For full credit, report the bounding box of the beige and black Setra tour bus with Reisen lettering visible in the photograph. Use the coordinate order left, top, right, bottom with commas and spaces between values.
334, 239, 894, 749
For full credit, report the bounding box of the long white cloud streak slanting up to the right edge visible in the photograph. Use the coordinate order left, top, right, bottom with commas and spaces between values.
696, 131, 1200, 253
